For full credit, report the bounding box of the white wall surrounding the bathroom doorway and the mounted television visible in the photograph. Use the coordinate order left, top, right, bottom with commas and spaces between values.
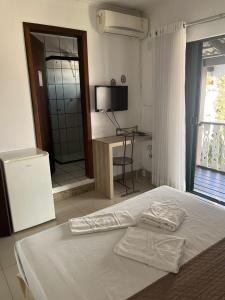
0, 0, 140, 152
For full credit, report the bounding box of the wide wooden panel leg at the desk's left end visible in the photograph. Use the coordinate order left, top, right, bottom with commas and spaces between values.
94, 141, 114, 199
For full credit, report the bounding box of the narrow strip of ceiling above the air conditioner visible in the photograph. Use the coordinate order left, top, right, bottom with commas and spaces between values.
77, 0, 163, 10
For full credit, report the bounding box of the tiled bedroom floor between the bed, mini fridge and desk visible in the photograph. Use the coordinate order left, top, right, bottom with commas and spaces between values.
0, 178, 153, 300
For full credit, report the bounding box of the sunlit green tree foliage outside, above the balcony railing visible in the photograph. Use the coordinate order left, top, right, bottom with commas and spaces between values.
215, 75, 225, 121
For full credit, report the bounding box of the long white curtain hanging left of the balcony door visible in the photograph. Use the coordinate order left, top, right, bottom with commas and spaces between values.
150, 22, 186, 191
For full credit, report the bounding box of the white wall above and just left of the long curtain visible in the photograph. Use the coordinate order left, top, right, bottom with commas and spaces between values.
141, 0, 225, 170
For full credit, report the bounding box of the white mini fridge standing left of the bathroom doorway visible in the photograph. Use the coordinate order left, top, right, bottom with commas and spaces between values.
0, 148, 55, 232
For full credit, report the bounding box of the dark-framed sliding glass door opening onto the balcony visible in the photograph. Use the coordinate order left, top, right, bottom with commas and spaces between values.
186, 37, 225, 203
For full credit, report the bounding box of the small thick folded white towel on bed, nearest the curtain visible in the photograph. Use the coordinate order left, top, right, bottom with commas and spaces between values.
140, 201, 186, 231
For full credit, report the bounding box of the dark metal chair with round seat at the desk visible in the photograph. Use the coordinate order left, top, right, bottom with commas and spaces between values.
113, 126, 138, 197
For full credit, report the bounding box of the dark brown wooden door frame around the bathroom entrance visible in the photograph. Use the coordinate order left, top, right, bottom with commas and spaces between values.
23, 22, 93, 178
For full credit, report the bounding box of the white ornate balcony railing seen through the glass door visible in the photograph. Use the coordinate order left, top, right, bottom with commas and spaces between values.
197, 122, 225, 172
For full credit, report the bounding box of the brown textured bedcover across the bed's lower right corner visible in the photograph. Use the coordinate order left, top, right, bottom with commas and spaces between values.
128, 239, 225, 300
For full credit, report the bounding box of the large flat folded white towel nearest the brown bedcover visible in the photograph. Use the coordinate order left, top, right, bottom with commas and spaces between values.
114, 227, 185, 273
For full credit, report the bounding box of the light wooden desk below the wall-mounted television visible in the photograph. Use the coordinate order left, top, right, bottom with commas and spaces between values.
93, 135, 151, 199
